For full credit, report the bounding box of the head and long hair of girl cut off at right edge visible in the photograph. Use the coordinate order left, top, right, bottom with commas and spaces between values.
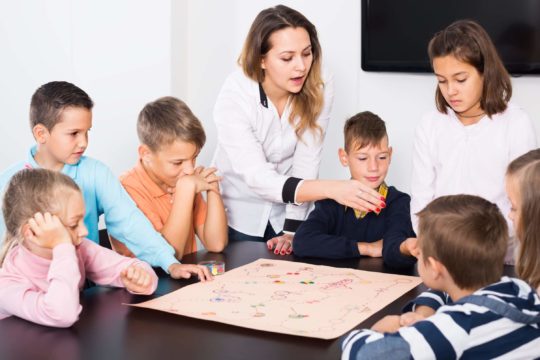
506, 149, 540, 288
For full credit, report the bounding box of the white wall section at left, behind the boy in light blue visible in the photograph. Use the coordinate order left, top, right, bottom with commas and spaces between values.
0, 0, 171, 175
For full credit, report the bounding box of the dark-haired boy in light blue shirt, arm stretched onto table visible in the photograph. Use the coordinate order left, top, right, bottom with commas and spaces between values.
0, 81, 211, 280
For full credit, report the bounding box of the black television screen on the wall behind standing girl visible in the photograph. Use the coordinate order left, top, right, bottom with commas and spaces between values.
361, 0, 540, 74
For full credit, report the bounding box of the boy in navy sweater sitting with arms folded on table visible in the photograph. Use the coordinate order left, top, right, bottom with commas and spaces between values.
293, 111, 416, 268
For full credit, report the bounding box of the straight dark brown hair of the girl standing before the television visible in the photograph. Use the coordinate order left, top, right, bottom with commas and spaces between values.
428, 20, 512, 117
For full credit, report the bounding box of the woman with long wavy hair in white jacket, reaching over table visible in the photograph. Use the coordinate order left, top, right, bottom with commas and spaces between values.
214, 5, 385, 254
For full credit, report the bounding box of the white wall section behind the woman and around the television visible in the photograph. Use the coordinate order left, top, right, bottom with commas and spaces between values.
173, 0, 540, 191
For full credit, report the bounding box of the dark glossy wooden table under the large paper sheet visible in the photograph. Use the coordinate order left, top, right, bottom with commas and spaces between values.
0, 242, 508, 360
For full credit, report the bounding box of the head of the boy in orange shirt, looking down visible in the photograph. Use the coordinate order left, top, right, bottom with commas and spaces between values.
137, 97, 206, 187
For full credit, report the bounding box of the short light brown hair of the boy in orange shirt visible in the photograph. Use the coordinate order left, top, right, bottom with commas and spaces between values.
137, 96, 206, 151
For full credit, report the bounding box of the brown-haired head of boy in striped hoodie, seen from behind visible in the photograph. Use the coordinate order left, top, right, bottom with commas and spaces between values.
418, 195, 508, 290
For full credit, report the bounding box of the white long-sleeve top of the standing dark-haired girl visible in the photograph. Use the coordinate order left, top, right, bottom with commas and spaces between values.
411, 103, 536, 235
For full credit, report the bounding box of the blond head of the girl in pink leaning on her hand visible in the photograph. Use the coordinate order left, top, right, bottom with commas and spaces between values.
0, 169, 88, 264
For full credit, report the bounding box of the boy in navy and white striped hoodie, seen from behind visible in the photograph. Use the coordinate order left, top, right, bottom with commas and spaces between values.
342, 195, 540, 359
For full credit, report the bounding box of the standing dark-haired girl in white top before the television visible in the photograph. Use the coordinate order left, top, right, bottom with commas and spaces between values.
411, 20, 536, 261
